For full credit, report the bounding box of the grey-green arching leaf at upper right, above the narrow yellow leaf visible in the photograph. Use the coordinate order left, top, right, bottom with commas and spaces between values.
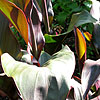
67, 10, 96, 33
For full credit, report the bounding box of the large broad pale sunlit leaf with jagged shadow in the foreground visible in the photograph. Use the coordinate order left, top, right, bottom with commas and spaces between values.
1, 46, 75, 100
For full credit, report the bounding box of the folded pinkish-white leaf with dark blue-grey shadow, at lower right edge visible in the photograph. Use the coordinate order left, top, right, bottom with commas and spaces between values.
81, 59, 100, 99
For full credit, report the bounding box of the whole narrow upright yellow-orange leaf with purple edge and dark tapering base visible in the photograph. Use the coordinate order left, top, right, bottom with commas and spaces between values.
74, 27, 86, 72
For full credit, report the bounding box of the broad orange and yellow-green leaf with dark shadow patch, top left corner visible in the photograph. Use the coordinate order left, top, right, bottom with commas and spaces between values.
0, 0, 28, 44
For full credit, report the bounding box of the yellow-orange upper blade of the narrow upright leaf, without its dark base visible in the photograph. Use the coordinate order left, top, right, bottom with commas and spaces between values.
75, 28, 86, 59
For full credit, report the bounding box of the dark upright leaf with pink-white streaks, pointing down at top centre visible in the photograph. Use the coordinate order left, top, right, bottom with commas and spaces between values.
33, 0, 54, 33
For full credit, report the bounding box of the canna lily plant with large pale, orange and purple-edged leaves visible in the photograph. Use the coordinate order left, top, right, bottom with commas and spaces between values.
0, 0, 100, 100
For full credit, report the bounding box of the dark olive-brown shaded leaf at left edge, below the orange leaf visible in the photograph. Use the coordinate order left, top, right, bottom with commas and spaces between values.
0, 12, 21, 58
